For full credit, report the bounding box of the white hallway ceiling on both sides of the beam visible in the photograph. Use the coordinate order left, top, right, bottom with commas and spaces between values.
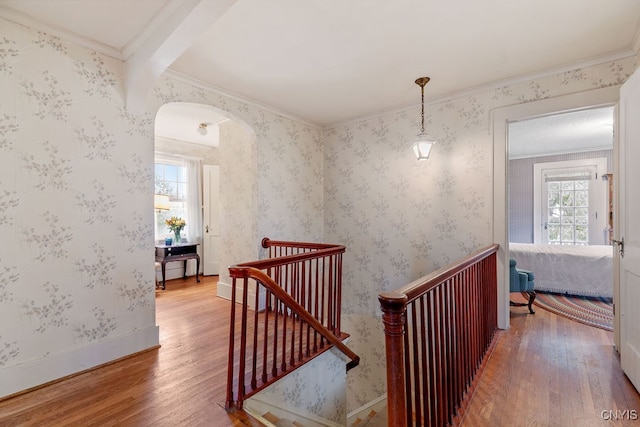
0, 0, 640, 153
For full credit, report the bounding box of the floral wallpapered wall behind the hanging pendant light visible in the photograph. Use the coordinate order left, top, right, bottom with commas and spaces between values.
324, 57, 636, 411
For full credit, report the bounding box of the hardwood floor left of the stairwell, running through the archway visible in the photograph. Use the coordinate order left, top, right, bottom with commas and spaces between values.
0, 277, 261, 427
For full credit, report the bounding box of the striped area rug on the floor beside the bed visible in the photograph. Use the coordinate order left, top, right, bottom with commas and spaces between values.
533, 292, 613, 331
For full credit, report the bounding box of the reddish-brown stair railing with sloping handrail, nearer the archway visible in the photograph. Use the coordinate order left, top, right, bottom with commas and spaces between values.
225, 238, 360, 409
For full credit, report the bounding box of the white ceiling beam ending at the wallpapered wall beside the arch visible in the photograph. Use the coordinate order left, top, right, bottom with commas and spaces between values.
124, 0, 237, 113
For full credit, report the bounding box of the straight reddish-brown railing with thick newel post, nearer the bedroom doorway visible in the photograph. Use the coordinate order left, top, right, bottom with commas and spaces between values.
378, 245, 499, 427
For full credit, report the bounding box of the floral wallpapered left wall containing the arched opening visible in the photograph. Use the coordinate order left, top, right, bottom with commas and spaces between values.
0, 18, 324, 397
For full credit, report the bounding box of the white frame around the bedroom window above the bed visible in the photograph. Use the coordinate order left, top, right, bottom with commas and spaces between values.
533, 157, 607, 245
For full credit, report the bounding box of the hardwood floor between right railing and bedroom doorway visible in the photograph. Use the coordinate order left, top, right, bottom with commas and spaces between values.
461, 294, 640, 427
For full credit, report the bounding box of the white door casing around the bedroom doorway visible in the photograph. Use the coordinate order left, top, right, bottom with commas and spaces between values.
492, 86, 619, 329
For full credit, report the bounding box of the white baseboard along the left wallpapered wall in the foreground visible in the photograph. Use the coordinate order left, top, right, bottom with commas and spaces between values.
0, 326, 160, 397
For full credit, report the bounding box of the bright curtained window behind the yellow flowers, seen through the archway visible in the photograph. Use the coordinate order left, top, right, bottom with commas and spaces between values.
155, 159, 189, 240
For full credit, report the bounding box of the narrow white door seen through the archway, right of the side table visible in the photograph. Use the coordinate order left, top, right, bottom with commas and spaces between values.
202, 165, 221, 276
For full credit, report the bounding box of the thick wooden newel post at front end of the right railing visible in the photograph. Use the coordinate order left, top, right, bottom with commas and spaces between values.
378, 292, 407, 427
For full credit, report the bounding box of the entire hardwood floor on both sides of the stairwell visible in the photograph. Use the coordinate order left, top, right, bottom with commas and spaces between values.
0, 277, 640, 427
